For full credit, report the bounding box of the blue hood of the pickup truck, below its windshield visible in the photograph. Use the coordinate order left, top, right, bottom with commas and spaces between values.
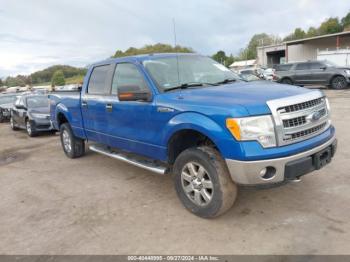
159, 81, 312, 115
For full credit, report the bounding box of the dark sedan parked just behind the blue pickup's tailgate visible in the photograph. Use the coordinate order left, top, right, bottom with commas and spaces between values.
10, 94, 54, 137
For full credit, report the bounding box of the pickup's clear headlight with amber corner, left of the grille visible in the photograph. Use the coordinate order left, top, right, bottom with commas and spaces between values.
226, 115, 276, 147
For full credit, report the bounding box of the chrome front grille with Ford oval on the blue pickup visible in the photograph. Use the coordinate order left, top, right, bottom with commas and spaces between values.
267, 91, 330, 146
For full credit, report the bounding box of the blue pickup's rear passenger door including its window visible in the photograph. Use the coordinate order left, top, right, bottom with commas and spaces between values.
80, 64, 114, 144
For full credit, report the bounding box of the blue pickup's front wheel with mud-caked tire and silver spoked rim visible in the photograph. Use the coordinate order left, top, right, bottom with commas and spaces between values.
173, 146, 237, 218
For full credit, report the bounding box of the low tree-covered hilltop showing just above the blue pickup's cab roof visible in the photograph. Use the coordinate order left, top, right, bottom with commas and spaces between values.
113, 43, 194, 57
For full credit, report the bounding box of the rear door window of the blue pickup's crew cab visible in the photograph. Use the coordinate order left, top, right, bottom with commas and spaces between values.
88, 65, 110, 95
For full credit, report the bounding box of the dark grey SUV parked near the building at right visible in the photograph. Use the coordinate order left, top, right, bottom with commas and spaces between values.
277, 61, 350, 89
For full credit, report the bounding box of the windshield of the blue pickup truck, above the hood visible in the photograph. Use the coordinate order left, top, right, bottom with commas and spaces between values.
143, 55, 240, 91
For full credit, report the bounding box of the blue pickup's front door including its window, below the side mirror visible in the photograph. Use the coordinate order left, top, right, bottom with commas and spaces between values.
108, 63, 164, 157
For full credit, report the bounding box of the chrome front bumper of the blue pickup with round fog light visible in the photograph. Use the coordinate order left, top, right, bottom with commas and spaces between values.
226, 136, 337, 185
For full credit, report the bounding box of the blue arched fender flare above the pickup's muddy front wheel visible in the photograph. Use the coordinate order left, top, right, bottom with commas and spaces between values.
162, 112, 233, 155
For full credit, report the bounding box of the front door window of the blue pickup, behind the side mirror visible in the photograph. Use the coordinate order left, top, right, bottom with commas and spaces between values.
112, 63, 149, 95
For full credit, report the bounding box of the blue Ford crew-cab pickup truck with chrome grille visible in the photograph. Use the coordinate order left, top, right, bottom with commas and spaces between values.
50, 54, 336, 218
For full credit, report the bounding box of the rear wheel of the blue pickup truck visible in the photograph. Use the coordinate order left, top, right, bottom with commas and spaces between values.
60, 123, 85, 158
